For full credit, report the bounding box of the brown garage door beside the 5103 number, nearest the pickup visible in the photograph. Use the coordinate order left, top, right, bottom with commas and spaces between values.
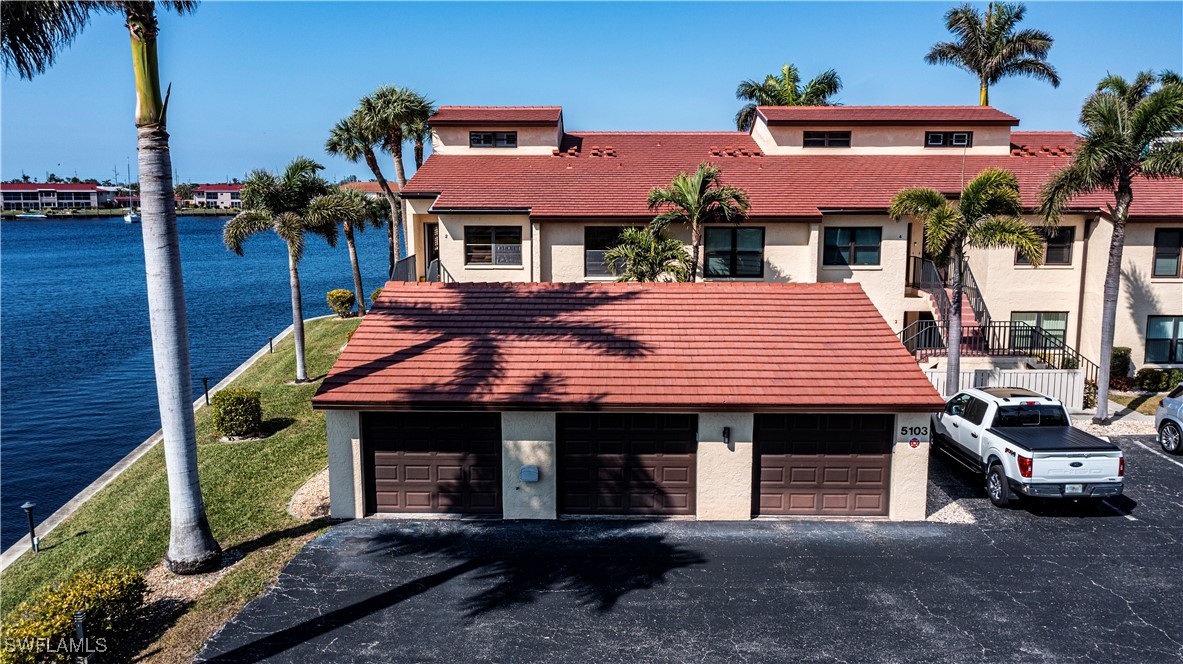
752, 414, 893, 516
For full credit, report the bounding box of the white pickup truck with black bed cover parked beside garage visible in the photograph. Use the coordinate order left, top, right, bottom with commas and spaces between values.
932, 387, 1125, 507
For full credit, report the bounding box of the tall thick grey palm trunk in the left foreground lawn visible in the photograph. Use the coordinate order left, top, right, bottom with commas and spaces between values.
127, 4, 221, 574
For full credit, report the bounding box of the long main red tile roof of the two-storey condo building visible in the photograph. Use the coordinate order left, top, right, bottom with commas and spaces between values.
405, 131, 1183, 220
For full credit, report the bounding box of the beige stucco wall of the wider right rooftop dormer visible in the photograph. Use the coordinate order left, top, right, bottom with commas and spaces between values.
751, 118, 1010, 155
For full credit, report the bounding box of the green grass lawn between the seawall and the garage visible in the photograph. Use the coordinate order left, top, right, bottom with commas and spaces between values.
0, 318, 358, 662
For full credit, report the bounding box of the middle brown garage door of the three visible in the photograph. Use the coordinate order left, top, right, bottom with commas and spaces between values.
556, 413, 698, 515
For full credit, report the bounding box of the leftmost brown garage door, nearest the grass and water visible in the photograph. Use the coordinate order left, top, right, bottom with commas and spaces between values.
362, 413, 502, 514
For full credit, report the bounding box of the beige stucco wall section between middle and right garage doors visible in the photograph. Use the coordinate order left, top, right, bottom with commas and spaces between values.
696, 413, 755, 521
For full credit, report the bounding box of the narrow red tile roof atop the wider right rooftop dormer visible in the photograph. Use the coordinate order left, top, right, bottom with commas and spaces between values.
756, 107, 1019, 127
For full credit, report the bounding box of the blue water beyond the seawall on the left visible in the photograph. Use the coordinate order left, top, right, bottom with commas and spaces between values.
0, 217, 387, 547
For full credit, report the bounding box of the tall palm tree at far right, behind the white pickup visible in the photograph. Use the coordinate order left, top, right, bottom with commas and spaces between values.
1040, 71, 1183, 424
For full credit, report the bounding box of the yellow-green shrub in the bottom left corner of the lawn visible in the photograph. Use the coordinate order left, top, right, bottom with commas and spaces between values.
0, 567, 148, 664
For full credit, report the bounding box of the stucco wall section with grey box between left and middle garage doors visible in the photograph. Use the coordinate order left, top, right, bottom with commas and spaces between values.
502, 412, 558, 518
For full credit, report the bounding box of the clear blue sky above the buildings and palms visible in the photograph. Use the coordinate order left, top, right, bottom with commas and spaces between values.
0, 0, 1183, 182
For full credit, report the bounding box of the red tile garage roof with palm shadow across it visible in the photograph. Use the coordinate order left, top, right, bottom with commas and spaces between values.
312, 282, 943, 412
